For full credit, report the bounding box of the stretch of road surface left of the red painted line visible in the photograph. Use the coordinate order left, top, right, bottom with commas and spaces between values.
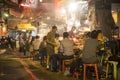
0, 49, 32, 80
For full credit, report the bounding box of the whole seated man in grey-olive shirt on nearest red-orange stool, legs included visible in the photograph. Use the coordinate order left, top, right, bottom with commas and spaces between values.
70, 30, 106, 77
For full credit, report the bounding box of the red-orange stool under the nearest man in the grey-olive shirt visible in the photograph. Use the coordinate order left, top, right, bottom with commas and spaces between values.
83, 64, 99, 80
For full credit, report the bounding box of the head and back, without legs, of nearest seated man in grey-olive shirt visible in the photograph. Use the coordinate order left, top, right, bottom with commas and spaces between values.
82, 31, 99, 63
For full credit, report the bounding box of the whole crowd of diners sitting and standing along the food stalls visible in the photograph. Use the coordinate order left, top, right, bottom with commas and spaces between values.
5, 26, 120, 79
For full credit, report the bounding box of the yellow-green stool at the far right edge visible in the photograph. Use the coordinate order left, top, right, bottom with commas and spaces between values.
106, 61, 118, 80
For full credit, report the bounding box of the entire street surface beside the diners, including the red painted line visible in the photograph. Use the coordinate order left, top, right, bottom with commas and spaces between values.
0, 50, 75, 80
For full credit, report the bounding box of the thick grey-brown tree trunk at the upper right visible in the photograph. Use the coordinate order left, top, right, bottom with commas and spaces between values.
95, 0, 115, 40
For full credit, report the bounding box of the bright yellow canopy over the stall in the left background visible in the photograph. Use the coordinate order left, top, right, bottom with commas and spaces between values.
17, 23, 35, 30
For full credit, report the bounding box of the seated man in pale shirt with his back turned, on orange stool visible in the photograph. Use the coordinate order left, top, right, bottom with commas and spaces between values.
59, 32, 74, 72
